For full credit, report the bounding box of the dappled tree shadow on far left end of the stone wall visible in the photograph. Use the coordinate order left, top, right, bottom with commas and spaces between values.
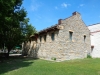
22, 41, 40, 58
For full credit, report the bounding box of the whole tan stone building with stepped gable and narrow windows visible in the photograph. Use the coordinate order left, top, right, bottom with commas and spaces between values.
22, 12, 91, 60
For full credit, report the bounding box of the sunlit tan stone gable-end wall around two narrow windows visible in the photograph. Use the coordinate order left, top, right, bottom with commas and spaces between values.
56, 13, 91, 59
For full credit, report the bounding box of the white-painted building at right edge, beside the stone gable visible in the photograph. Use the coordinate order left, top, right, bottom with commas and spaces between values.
88, 23, 100, 58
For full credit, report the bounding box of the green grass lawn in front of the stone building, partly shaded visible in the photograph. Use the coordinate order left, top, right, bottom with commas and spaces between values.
0, 58, 100, 75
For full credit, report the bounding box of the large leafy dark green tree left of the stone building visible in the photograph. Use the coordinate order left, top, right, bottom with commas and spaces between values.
0, 0, 36, 56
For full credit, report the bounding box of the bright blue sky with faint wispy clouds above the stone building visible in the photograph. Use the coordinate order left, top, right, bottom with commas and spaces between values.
22, 0, 100, 31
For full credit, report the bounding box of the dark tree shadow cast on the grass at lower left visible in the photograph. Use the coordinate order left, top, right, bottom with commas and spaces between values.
0, 56, 34, 75
